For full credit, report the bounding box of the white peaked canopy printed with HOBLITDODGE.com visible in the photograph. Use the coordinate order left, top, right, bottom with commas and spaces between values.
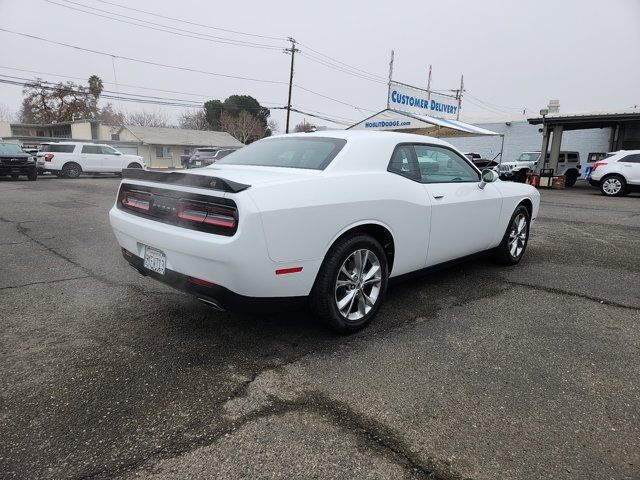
347, 108, 501, 138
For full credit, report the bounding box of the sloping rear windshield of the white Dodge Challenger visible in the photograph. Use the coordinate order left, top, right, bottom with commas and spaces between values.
216, 137, 347, 170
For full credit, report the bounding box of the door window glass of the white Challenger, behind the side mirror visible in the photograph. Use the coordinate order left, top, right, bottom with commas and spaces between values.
414, 145, 480, 183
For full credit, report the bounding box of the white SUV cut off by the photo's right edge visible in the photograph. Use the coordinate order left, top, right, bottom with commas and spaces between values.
589, 150, 640, 197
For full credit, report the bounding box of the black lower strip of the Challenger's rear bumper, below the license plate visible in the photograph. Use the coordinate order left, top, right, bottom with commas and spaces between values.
122, 248, 307, 314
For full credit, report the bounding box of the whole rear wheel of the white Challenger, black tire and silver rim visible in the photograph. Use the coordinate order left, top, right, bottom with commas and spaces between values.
310, 233, 389, 334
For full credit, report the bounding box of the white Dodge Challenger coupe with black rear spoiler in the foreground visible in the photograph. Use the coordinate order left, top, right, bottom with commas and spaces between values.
109, 131, 540, 332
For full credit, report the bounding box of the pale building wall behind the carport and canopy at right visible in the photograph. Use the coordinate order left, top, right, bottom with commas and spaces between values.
444, 121, 611, 164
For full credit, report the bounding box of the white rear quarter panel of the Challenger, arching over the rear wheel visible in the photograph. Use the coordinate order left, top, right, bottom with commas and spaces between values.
247, 171, 430, 275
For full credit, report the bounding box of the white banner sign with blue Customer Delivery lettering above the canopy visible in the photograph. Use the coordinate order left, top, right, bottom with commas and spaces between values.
388, 82, 459, 119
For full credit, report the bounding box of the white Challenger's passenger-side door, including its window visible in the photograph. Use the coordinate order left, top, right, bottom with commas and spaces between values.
414, 144, 502, 266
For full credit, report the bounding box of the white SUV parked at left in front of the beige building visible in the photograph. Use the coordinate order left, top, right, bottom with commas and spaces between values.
38, 142, 144, 178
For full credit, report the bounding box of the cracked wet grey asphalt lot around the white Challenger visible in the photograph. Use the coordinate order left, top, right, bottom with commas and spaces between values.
0, 177, 640, 480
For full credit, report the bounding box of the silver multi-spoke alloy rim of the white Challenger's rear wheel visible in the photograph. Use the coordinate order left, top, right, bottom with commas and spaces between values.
334, 249, 382, 321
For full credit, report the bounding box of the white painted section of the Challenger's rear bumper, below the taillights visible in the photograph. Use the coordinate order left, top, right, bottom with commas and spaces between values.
109, 207, 322, 299
